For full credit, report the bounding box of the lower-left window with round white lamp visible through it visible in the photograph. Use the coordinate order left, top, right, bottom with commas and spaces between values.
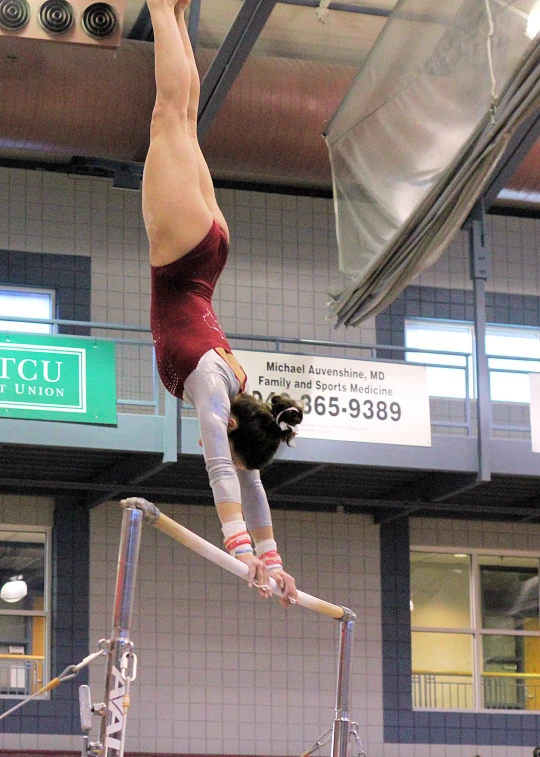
0, 526, 49, 697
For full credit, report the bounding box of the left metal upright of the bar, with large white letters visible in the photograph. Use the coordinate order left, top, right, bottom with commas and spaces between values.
100, 507, 143, 757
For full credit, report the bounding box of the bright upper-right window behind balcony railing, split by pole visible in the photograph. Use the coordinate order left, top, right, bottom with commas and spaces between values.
405, 320, 540, 403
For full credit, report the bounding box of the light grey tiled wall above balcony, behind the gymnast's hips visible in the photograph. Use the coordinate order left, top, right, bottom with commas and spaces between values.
0, 168, 373, 343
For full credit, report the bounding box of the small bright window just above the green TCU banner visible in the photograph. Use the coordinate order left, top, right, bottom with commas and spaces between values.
0, 286, 55, 334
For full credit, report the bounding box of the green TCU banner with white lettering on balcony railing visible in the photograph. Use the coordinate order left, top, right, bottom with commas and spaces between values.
0, 332, 116, 426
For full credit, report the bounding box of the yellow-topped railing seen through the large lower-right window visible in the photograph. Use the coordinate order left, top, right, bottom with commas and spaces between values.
411, 671, 540, 710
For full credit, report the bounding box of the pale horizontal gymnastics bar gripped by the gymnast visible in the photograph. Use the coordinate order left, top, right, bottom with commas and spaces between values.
121, 497, 354, 620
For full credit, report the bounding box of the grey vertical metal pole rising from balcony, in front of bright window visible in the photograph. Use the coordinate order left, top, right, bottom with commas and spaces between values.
467, 200, 492, 481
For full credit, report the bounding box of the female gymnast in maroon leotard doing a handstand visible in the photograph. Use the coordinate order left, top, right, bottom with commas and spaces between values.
143, 0, 302, 606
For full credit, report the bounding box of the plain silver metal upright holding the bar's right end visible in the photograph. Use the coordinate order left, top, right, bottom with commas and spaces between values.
331, 607, 356, 757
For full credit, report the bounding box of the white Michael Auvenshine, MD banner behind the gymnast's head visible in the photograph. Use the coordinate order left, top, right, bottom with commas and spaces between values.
234, 349, 431, 447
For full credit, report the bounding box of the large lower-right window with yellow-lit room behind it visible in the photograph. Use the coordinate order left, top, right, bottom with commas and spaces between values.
411, 549, 540, 711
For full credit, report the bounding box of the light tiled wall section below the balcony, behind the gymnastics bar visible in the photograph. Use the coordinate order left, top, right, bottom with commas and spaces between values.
85, 503, 382, 755
